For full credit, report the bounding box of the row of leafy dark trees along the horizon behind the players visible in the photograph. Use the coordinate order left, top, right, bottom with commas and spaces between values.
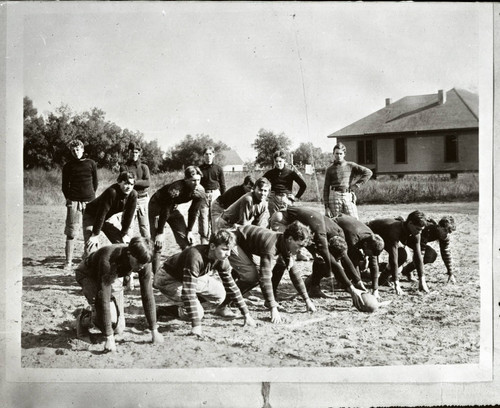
23, 96, 331, 173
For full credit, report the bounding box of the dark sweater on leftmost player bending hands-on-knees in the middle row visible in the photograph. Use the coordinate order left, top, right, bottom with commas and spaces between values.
85, 183, 137, 235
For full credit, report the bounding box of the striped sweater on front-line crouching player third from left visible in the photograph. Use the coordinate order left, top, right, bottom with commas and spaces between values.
236, 225, 309, 308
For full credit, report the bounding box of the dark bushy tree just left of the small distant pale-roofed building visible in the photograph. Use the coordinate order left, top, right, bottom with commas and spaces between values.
162, 134, 229, 171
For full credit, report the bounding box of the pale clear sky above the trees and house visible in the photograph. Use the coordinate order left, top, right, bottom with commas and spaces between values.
23, 2, 487, 161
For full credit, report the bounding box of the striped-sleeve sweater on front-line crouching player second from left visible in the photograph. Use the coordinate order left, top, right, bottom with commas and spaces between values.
163, 245, 248, 327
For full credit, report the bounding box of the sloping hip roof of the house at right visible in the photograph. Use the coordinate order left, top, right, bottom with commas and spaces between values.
328, 88, 479, 137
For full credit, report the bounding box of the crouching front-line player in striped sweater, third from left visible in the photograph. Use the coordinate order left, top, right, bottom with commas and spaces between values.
220, 221, 316, 323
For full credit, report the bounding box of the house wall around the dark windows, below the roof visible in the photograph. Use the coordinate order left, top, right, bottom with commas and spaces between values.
338, 131, 479, 174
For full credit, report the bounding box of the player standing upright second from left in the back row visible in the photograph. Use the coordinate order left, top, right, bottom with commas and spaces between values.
120, 142, 149, 238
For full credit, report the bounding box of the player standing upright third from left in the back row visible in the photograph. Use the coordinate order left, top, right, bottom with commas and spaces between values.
198, 146, 226, 244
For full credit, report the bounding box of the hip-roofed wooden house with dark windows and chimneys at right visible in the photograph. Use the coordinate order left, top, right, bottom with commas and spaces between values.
328, 88, 479, 177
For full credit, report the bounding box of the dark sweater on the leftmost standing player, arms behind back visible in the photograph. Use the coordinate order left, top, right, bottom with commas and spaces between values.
62, 159, 99, 202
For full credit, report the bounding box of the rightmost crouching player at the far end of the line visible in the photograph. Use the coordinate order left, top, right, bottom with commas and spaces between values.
401, 215, 457, 283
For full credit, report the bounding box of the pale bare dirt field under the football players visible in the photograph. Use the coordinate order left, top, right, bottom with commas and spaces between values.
21, 202, 480, 368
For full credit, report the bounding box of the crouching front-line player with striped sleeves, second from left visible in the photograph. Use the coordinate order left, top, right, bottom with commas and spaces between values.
154, 229, 255, 336
